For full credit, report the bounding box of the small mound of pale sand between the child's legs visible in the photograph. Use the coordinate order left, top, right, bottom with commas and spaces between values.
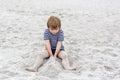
39, 57, 63, 77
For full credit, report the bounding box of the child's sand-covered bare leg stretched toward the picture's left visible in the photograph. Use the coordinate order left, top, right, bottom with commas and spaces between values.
26, 50, 49, 72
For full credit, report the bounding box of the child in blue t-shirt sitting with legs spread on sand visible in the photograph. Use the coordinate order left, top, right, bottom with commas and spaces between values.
26, 16, 76, 72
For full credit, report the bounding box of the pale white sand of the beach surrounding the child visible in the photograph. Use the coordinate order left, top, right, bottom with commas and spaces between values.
0, 0, 120, 80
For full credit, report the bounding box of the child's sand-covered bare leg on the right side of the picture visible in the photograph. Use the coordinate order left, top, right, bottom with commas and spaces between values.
58, 51, 76, 70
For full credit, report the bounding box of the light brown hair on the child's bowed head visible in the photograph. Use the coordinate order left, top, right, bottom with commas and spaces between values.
47, 16, 61, 29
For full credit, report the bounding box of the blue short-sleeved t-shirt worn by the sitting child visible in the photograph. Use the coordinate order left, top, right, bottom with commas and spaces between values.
44, 29, 64, 52
